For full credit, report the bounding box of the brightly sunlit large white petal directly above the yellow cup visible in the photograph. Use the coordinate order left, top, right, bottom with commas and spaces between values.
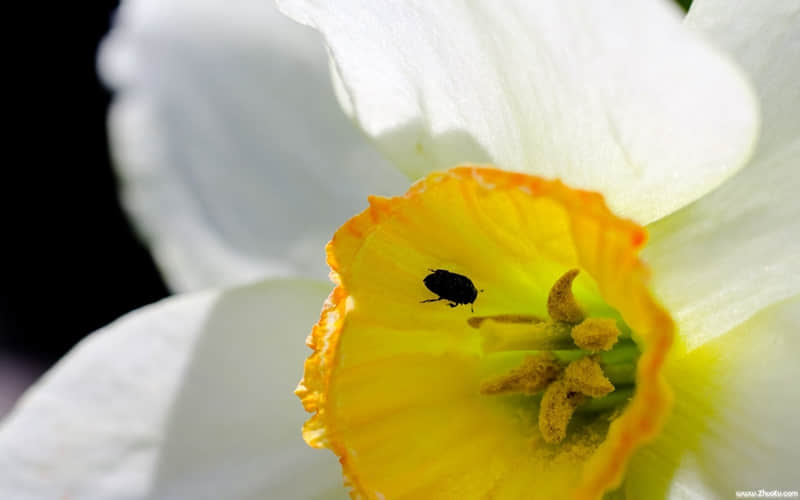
278, 0, 757, 222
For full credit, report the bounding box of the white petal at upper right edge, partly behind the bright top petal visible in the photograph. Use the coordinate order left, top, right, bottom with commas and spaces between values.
645, 0, 800, 346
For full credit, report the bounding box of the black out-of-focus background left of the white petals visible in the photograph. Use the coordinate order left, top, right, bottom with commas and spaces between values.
0, 1, 167, 410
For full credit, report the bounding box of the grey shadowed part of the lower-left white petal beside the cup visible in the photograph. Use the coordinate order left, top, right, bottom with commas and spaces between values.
150, 281, 346, 500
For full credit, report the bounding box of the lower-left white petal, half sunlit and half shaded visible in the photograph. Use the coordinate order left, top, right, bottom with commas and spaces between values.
0, 281, 345, 500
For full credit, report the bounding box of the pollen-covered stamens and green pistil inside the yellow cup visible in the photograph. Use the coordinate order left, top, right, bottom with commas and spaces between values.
476, 269, 638, 444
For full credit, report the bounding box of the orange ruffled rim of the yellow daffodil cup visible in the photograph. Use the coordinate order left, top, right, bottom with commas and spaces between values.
295, 166, 674, 499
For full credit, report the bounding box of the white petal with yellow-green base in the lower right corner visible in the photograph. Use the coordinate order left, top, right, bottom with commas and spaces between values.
625, 296, 800, 498
